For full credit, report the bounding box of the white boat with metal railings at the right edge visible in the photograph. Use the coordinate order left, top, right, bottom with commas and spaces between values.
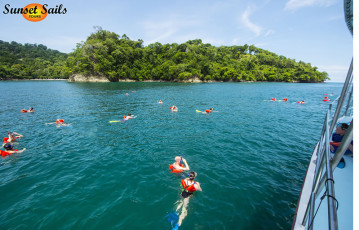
292, 0, 353, 230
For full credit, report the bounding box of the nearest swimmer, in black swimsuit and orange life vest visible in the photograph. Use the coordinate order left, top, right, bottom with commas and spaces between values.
176, 172, 202, 226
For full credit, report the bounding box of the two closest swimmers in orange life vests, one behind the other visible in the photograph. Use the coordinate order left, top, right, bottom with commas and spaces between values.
169, 156, 202, 229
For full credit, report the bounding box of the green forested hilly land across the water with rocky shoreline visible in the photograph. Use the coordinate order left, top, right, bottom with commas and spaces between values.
0, 27, 329, 82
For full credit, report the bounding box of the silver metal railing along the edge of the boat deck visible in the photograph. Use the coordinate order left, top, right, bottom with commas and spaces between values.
301, 59, 353, 230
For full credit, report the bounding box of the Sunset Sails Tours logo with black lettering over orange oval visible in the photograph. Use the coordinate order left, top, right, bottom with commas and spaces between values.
3, 3, 67, 22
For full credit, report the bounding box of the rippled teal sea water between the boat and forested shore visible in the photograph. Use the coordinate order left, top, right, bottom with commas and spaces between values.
0, 81, 342, 230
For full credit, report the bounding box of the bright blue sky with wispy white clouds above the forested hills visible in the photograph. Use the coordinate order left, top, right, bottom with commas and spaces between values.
0, 0, 353, 82
